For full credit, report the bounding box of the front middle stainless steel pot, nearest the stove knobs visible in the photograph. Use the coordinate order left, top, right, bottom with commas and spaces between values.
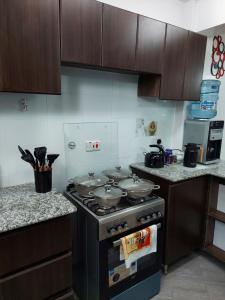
89, 185, 127, 207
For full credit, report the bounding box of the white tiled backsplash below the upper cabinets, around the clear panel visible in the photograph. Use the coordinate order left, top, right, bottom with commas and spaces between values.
0, 67, 184, 190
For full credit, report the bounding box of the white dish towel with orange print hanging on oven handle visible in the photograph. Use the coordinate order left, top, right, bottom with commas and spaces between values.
120, 225, 157, 268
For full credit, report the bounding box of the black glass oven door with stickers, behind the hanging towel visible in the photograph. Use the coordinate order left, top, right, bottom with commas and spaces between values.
99, 219, 163, 300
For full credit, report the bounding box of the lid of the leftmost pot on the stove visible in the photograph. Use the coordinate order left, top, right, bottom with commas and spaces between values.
74, 173, 109, 187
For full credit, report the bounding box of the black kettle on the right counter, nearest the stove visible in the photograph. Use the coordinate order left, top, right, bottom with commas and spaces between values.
145, 145, 165, 168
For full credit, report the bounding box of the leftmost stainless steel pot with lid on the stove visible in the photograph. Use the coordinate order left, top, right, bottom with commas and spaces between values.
74, 173, 113, 197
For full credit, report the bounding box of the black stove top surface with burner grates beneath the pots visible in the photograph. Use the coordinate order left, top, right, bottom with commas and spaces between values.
69, 191, 158, 216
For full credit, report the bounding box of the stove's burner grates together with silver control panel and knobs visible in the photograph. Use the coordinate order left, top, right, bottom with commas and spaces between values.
65, 189, 165, 240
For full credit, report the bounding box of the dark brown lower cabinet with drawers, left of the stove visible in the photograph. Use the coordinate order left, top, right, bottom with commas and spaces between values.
0, 214, 74, 300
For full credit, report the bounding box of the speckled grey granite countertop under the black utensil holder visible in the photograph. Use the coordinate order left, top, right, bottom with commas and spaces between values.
0, 184, 76, 233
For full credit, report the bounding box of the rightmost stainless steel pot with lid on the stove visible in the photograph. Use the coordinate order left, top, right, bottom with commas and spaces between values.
114, 175, 160, 199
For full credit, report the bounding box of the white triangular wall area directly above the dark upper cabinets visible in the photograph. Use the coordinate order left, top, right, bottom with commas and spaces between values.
98, 0, 195, 29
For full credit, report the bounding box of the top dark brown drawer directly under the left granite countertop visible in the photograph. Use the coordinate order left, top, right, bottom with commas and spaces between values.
0, 215, 73, 277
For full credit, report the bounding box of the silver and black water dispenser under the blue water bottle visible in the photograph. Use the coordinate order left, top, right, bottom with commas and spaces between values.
183, 120, 224, 164
